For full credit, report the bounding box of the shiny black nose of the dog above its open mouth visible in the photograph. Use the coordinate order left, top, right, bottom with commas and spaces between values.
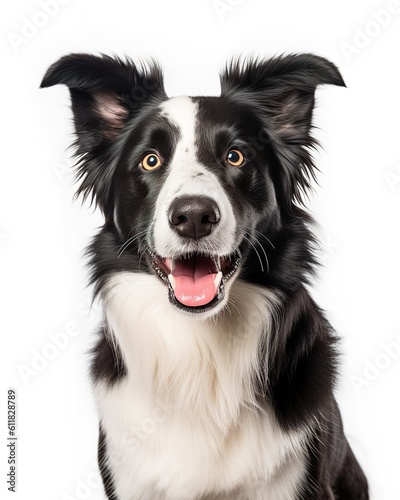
169, 196, 220, 240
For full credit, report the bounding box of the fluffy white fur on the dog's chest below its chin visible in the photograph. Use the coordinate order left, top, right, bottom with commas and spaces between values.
95, 273, 305, 500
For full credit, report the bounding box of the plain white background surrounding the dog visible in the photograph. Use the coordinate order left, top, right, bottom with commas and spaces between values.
0, 0, 400, 500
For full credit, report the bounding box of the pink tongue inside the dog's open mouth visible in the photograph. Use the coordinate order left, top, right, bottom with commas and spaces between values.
172, 257, 218, 307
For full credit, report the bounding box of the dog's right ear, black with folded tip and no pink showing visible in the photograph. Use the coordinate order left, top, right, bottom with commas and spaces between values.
221, 54, 345, 208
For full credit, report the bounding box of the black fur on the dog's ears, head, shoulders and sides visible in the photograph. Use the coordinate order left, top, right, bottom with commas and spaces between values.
41, 54, 368, 500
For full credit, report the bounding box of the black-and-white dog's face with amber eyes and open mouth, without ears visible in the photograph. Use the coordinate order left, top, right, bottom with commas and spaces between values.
113, 97, 278, 315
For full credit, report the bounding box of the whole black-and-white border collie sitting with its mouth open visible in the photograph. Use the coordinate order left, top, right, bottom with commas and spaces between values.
41, 54, 369, 500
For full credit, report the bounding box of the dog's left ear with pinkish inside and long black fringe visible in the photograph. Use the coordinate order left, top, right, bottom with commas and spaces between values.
40, 54, 167, 211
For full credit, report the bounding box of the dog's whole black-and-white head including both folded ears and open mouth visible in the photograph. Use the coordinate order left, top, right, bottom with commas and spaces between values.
41, 54, 344, 317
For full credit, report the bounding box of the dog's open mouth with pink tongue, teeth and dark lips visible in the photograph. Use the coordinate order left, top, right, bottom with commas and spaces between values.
150, 250, 241, 312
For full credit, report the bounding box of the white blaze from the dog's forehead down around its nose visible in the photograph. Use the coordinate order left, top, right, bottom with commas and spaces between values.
153, 97, 236, 257
